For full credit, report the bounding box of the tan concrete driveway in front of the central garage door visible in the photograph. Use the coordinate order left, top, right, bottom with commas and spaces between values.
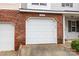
19, 44, 76, 56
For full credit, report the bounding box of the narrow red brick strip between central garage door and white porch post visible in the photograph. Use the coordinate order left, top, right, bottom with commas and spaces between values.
57, 15, 63, 44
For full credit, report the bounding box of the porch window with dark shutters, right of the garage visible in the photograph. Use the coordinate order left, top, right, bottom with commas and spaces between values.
68, 21, 79, 32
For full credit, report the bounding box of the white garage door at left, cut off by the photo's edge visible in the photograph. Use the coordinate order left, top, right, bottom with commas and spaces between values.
0, 24, 14, 51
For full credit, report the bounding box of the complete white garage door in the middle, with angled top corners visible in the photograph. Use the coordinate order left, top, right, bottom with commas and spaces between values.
26, 18, 57, 44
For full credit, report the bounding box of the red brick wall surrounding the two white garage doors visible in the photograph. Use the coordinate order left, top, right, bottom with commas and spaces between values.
0, 10, 63, 50
